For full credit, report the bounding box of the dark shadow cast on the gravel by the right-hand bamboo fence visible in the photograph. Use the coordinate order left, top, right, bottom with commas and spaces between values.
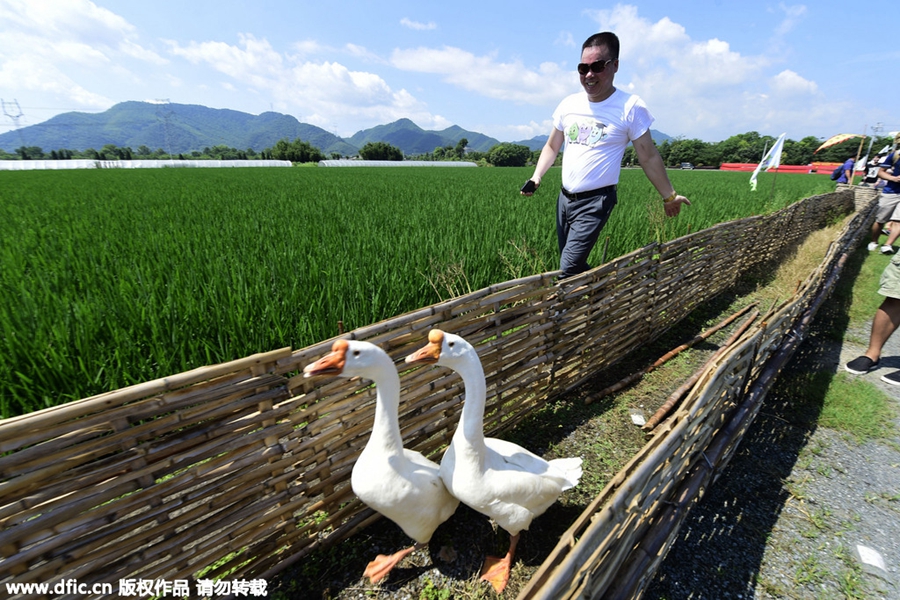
643, 245, 865, 600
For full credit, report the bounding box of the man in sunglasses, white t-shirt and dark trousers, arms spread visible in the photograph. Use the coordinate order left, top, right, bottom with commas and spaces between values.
522, 32, 690, 278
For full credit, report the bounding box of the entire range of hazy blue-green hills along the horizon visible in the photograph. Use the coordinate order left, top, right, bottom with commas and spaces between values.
0, 102, 672, 156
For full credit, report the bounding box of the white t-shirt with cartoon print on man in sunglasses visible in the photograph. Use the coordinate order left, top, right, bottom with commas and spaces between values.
553, 88, 654, 192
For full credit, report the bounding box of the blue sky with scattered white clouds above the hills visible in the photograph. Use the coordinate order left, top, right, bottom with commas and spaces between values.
0, 0, 900, 141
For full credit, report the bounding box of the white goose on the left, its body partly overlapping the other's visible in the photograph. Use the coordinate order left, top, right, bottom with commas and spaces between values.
303, 340, 459, 583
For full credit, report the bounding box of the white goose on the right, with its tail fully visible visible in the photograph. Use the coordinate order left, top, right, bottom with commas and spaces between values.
406, 329, 581, 594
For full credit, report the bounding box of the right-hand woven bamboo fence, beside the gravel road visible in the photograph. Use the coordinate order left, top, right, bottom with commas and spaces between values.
519, 191, 874, 599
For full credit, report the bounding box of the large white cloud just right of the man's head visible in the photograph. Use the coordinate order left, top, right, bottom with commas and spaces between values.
576, 4, 845, 141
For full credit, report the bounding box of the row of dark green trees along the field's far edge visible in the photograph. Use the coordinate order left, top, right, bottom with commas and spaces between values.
0, 131, 892, 168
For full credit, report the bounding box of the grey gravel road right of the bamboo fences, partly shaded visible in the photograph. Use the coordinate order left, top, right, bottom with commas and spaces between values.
644, 298, 900, 600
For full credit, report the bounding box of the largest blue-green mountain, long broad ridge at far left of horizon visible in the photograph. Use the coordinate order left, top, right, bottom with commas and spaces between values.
0, 102, 357, 155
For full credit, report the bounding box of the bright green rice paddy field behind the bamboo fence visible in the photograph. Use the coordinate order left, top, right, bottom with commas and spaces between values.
0, 167, 834, 418
